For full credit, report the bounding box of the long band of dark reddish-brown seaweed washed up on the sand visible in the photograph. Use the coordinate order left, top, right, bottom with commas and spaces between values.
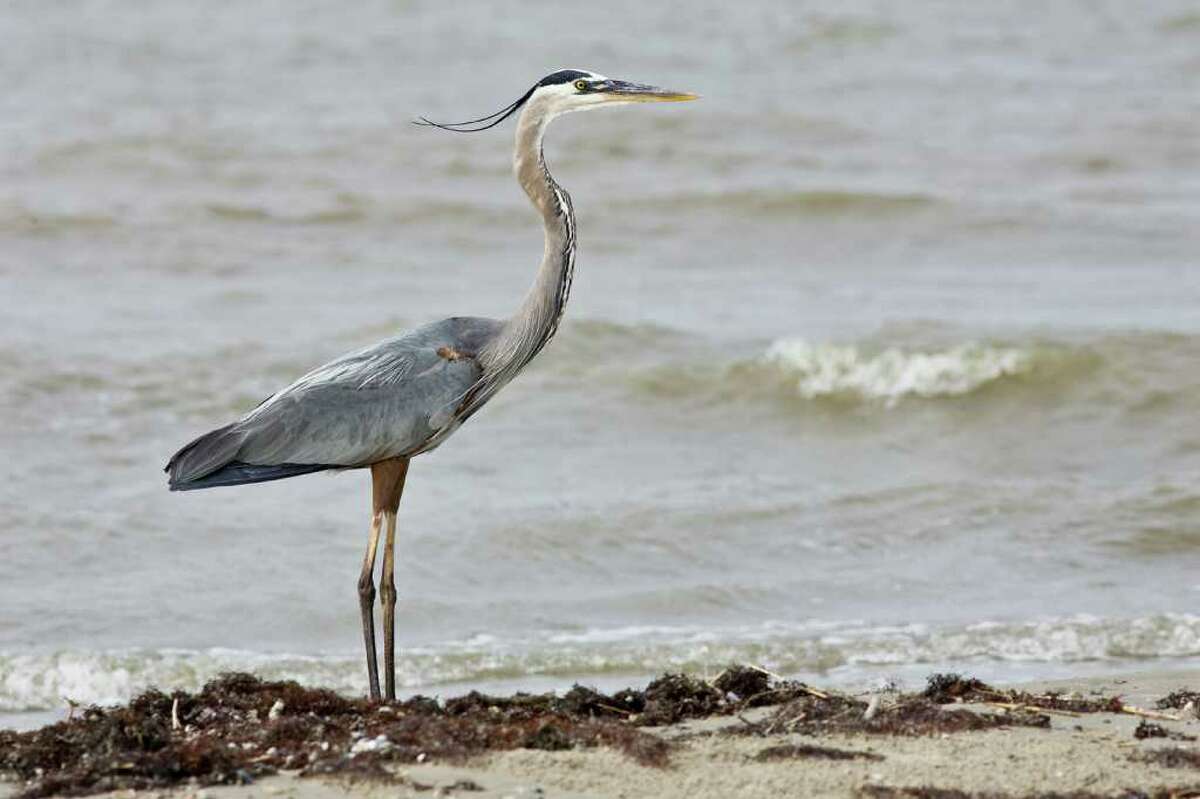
0, 666, 1182, 799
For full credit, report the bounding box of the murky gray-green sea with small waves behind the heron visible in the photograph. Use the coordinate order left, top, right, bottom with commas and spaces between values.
0, 0, 1200, 725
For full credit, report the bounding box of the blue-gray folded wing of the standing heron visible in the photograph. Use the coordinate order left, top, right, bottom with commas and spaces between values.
168, 317, 500, 485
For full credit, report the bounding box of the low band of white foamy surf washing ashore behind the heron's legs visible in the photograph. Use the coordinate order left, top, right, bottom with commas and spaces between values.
0, 614, 1200, 713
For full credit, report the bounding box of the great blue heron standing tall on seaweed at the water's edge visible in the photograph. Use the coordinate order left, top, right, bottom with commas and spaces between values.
167, 70, 696, 699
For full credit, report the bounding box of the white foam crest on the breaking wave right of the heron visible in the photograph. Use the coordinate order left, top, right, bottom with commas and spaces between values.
764, 338, 1033, 405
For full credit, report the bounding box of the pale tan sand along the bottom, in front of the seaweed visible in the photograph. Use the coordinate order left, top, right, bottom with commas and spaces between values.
0, 671, 1200, 799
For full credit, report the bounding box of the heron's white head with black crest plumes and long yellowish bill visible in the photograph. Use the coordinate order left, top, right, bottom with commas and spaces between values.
416, 70, 698, 133
